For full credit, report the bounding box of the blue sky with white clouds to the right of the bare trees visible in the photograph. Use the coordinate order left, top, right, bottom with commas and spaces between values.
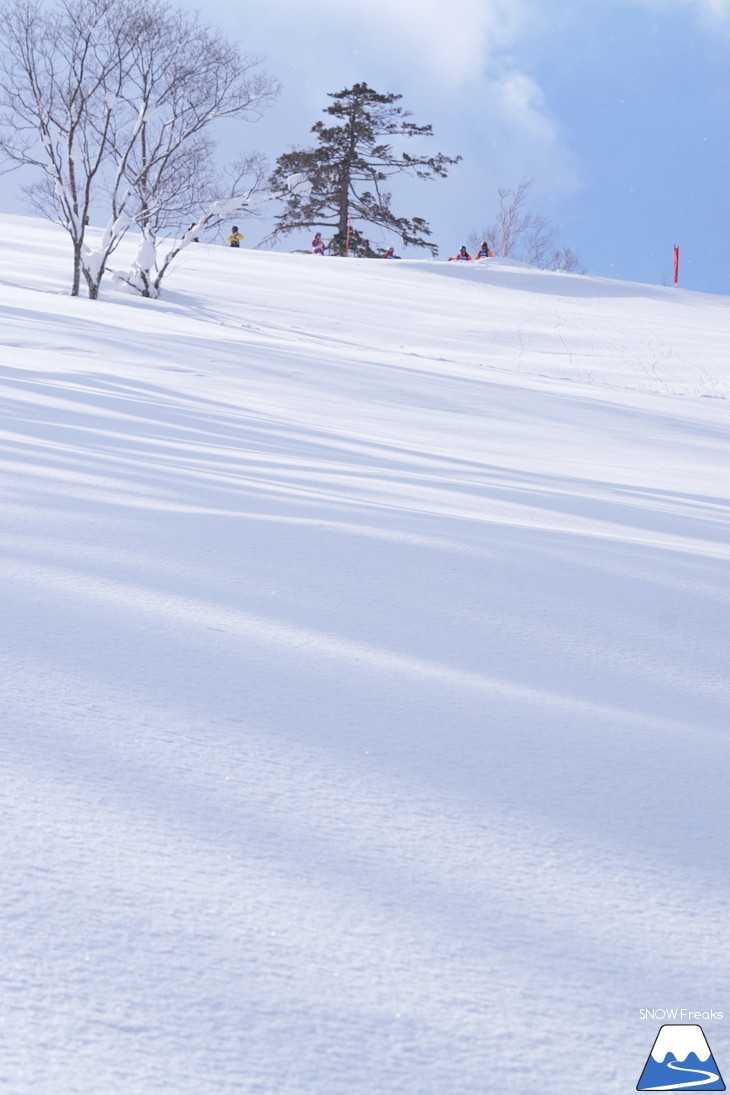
0, 0, 730, 295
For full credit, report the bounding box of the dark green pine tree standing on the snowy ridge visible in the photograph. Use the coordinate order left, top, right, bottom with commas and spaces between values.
269, 83, 461, 256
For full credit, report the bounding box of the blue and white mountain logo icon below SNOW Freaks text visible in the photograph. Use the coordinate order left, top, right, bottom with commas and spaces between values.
636, 1023, 726, 1092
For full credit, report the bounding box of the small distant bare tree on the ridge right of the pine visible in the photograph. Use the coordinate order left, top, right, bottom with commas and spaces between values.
466, 177, 584, 274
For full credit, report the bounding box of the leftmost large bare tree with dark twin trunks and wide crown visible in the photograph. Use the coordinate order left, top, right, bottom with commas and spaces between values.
0, 0, 278, 298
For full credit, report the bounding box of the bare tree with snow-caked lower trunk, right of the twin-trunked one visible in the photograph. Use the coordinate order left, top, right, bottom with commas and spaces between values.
107, 3, 279, 296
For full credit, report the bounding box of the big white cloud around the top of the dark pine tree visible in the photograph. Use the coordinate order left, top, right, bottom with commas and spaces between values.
237, 0, 576, 213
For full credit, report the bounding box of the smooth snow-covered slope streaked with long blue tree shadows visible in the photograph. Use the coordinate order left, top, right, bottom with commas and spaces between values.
0, 217, 730, 1095
